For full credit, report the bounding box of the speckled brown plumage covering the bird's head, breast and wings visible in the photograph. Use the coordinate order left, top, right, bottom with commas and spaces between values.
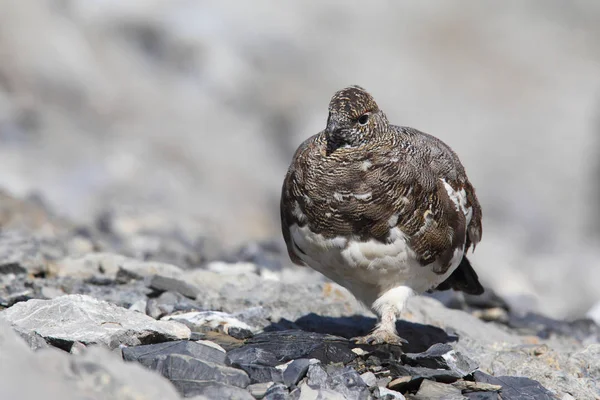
281, 88, 482, 280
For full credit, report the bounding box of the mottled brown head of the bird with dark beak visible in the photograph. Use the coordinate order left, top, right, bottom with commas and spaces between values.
325, 86, 388, 148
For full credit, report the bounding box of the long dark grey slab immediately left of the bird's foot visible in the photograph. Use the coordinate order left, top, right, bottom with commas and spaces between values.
227, 331, 356, 366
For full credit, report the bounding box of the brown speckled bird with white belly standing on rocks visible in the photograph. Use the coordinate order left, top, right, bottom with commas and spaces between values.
280, 85, 484, 346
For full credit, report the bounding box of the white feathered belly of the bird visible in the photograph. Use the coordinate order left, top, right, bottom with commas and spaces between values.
290, 225, 463, 306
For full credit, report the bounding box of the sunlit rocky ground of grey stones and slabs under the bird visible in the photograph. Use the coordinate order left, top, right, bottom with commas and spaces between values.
0, 193, 600, 400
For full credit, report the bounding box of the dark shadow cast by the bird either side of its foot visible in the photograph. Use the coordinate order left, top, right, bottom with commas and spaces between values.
265, 313, 458, 353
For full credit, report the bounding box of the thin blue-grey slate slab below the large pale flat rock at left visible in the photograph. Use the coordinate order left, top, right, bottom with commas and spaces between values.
123, 340, 225, 368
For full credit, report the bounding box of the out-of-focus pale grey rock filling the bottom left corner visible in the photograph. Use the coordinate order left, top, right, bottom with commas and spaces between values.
0, 321, 180, 400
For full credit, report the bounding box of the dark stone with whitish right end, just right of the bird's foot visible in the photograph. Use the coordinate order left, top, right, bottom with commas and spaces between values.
402, 343, 477, 376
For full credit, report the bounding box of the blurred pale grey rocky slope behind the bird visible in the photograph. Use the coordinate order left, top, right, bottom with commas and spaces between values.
0, 0, 600, 318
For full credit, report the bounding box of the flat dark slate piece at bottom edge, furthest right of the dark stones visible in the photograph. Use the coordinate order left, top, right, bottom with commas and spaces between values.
473, 371, 556, 400
